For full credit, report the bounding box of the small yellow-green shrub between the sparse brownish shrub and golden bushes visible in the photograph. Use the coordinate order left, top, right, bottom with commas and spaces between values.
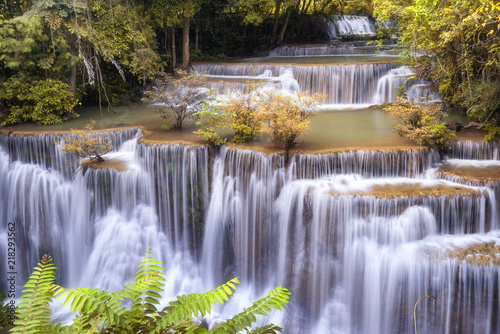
194, 88, 228, 146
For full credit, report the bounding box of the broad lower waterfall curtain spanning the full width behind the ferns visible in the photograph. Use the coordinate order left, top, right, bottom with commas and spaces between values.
0, 130, 500, 334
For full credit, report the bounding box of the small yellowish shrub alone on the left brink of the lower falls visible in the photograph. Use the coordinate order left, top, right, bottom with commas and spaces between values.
61, 120, 113, 162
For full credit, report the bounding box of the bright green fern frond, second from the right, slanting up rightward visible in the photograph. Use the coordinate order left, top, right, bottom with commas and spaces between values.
153, 277, 239, 333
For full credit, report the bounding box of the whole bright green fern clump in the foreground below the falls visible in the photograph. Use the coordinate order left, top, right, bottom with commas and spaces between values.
11, 249, 290, 334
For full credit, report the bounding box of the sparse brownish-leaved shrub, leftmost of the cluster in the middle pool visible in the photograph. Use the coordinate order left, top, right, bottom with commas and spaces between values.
142, 70, 207, 130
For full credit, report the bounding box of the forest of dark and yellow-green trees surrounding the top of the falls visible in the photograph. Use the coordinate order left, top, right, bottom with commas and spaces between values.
0, 0, 500, 135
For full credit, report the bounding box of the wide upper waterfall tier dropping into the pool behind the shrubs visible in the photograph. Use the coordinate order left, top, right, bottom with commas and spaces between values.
194, 63, 439, 104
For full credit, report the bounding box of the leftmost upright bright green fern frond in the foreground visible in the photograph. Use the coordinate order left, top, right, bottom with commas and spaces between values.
10, 255, 57, 334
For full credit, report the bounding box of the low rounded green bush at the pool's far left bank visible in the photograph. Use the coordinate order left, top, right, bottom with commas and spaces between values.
5, 79, 78, 124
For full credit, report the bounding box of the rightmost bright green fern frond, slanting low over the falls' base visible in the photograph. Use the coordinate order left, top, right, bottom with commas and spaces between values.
208, 286, 291, 334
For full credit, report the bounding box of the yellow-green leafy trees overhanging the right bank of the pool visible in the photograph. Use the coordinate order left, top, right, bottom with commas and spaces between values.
374, 0, 500, 140
